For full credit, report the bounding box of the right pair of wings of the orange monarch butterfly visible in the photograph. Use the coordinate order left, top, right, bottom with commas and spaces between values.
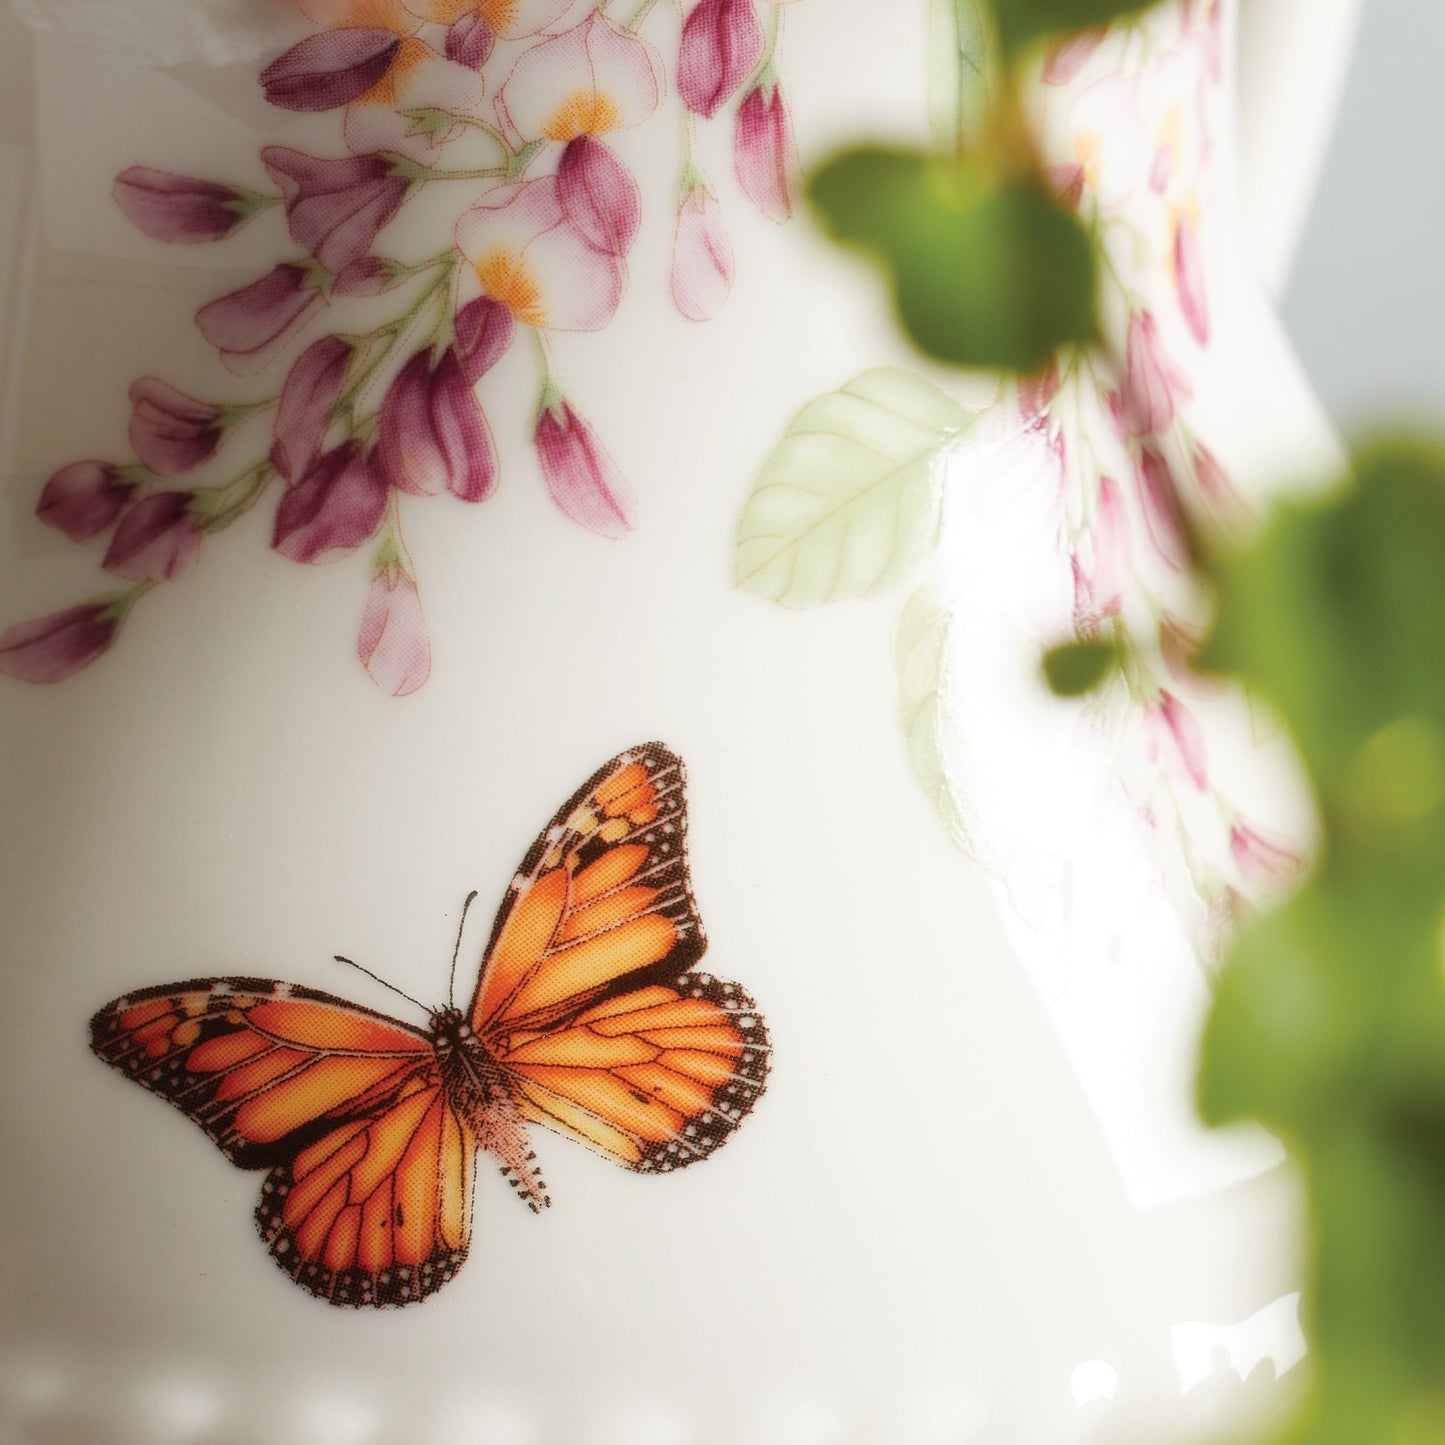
471, 743, 769, 1172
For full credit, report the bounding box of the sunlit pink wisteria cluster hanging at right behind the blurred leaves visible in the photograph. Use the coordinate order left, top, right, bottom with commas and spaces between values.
1034, 0, 1305, 942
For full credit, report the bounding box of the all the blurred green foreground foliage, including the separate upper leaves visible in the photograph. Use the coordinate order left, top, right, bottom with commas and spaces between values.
811, 0, 1445, 1445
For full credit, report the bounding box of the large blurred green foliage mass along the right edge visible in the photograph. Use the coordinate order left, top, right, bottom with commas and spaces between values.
1201, 442, 1445, 1445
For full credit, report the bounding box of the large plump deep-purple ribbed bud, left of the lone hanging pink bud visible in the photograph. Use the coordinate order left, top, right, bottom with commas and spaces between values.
377, 348, 497, 501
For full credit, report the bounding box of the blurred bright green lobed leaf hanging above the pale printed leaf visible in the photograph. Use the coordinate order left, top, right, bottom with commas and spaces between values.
809, 146, 1098, 373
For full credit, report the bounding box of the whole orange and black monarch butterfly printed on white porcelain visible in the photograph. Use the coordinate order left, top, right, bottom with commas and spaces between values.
91, 743, 769, 1306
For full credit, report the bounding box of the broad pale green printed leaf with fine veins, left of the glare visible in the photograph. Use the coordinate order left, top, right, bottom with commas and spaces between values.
734, 367, 974, 607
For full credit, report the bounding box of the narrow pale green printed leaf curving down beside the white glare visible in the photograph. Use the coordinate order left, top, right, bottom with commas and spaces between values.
893, 587, 974, 854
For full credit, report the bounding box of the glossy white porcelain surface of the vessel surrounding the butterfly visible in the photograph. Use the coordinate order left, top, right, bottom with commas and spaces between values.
0, 0, 1335, 1445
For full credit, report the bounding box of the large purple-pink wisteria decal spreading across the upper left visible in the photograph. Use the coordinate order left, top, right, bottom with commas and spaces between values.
0, 0, 796, 696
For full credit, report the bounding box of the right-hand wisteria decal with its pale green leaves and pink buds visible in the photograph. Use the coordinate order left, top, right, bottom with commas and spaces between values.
736, 0, 1305, 949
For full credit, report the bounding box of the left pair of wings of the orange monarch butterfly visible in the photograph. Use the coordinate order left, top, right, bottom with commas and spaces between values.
91, 978, 475, 1305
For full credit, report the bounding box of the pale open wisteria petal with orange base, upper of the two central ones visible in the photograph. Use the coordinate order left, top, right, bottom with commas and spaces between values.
497, 10, 663, 142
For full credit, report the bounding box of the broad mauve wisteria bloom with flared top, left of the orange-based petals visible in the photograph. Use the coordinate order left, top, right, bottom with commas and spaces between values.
262, 146, 410, 272
